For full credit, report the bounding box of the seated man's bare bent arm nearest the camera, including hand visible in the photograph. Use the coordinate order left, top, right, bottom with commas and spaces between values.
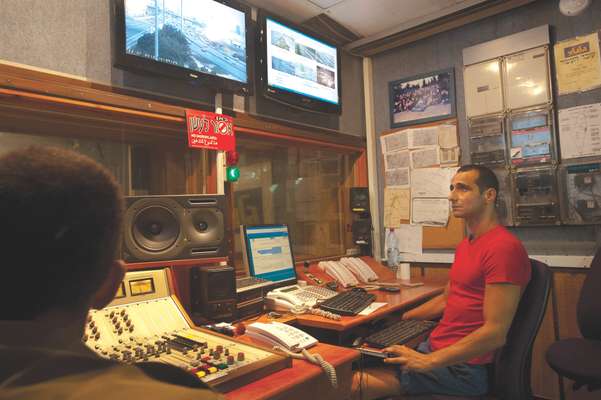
384, 283, 521, 371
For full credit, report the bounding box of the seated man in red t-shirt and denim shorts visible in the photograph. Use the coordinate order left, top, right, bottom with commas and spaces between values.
353, 165, 530, 399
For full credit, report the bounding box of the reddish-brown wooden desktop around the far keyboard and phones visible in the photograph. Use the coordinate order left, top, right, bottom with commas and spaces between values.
296, 257, 446, 331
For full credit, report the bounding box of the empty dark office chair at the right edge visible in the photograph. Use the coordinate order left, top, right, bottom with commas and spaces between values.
547, 249, 601, 391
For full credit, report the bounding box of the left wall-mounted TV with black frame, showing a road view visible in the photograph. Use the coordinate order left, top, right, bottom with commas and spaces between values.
115, 0, 251, 94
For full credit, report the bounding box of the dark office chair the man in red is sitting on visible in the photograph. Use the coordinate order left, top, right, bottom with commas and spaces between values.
402, 259, 551, 400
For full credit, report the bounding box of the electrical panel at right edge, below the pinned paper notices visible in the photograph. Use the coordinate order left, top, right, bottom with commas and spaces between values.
560, 163, 601, 225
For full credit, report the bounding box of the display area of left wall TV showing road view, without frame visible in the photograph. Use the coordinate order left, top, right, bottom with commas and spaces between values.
125, 0, 248, 83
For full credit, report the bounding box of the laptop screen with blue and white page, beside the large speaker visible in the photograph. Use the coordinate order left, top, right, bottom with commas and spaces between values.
240, 224, 297, 287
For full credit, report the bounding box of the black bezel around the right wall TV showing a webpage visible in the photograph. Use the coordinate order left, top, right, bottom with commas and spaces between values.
257, 10, 342, 114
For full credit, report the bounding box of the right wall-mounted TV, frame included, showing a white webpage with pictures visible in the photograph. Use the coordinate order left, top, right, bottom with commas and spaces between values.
259, 12, 341, 113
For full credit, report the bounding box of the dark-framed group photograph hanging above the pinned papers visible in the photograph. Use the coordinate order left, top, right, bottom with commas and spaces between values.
388, 68, 455, 128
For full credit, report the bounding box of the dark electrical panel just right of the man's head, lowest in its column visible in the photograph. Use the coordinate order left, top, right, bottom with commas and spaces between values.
512, 167, 560, 226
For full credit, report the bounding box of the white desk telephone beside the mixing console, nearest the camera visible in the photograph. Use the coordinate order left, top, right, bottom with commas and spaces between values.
246, 322, 317, 351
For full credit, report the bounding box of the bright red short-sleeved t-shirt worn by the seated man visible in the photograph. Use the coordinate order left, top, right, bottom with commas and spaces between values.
430, 225, 531, 364
